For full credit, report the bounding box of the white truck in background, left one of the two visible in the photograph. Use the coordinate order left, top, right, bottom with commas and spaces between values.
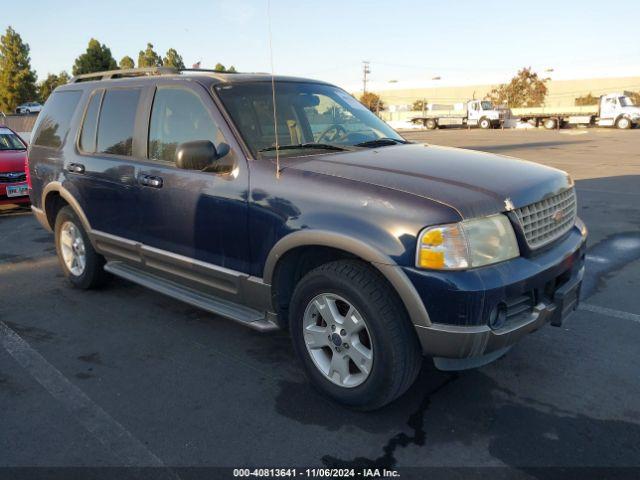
411, 100, 504, 130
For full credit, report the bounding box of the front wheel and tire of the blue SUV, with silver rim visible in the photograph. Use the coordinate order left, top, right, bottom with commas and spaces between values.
289, 260, 422, 410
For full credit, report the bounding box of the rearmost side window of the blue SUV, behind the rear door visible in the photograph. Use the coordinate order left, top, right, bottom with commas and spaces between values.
33, 90, 82, 148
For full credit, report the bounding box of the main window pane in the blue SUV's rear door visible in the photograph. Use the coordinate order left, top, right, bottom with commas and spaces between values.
96, 88, 140, 157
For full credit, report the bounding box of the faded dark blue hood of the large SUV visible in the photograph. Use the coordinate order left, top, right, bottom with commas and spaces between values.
283, 144, 572, 218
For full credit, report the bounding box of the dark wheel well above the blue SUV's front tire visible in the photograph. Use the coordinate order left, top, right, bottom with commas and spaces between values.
271, 245, 360, 328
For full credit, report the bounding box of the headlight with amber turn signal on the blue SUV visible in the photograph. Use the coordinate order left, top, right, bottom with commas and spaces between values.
416, 214, 520, 270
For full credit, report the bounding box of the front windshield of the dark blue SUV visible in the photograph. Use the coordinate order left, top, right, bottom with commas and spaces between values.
216, 82, 405, 155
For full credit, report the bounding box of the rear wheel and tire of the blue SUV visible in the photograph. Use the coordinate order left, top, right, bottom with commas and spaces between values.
54, 206, 109, 290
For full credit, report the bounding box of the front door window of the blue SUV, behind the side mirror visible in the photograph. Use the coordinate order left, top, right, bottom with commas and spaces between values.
148, 87, 223, 163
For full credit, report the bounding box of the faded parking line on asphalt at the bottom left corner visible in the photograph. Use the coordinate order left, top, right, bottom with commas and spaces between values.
0, 321, 175, 470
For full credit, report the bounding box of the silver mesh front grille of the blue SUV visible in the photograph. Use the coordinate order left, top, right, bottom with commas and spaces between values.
514, 188, 577, 249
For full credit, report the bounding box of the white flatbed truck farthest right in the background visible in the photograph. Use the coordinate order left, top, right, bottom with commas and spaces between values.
511, 93, 640, 129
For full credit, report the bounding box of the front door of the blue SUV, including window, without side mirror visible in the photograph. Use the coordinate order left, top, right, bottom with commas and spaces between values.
138, 81, 249, 272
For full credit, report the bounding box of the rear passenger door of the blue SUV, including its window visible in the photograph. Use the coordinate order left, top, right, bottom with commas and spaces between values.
72, 86, 150, 240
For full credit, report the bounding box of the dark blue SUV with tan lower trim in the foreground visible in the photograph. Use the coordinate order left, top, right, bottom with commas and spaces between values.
29, 69, 587, 409
